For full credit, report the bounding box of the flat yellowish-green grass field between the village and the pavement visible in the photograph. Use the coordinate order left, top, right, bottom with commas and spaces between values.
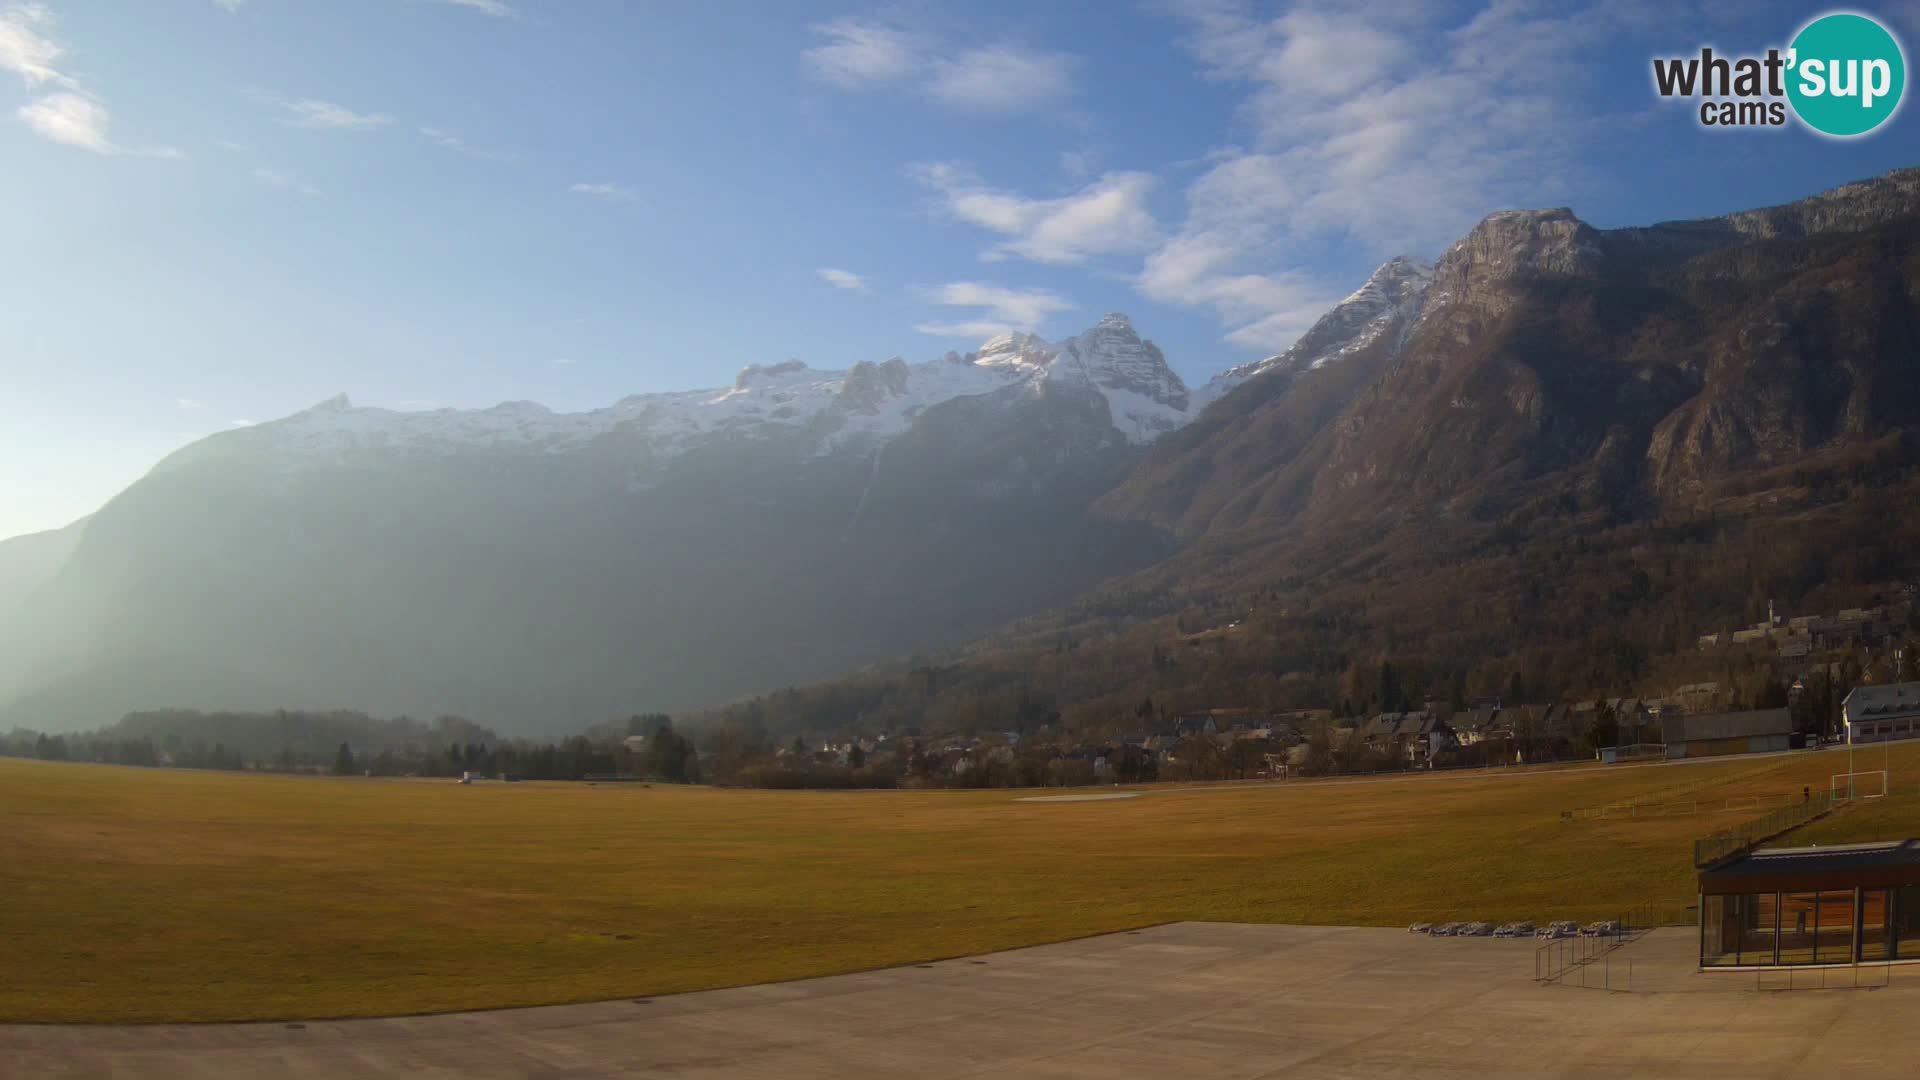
11, 748, 1920, 1020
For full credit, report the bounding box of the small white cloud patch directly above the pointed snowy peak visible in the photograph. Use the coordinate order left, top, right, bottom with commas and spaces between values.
908, 161, 1160, 265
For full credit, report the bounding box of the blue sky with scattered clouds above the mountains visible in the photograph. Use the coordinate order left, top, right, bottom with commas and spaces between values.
0, 0, 1920, 536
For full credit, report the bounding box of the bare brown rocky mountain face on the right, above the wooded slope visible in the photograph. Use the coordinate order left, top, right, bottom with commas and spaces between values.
1100, 169, 1920, 536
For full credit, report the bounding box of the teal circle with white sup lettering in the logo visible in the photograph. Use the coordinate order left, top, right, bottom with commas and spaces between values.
1788, 12, 1907, 138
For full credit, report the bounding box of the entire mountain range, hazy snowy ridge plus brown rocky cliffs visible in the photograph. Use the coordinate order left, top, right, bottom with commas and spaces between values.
0, 169, 1920, 732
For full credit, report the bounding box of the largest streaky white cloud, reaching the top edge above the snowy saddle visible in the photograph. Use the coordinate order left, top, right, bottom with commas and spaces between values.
1139, 0, 1634, 350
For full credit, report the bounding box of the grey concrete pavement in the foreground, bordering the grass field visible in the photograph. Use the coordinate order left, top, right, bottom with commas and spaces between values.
0, 922, 1920, 1080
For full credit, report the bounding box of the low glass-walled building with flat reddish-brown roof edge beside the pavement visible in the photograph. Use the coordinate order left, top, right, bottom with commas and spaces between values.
1699, 840, 1920, 969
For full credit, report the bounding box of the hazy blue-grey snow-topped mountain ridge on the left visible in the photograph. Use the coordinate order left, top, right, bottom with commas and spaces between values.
0, 315, 1190, 730
